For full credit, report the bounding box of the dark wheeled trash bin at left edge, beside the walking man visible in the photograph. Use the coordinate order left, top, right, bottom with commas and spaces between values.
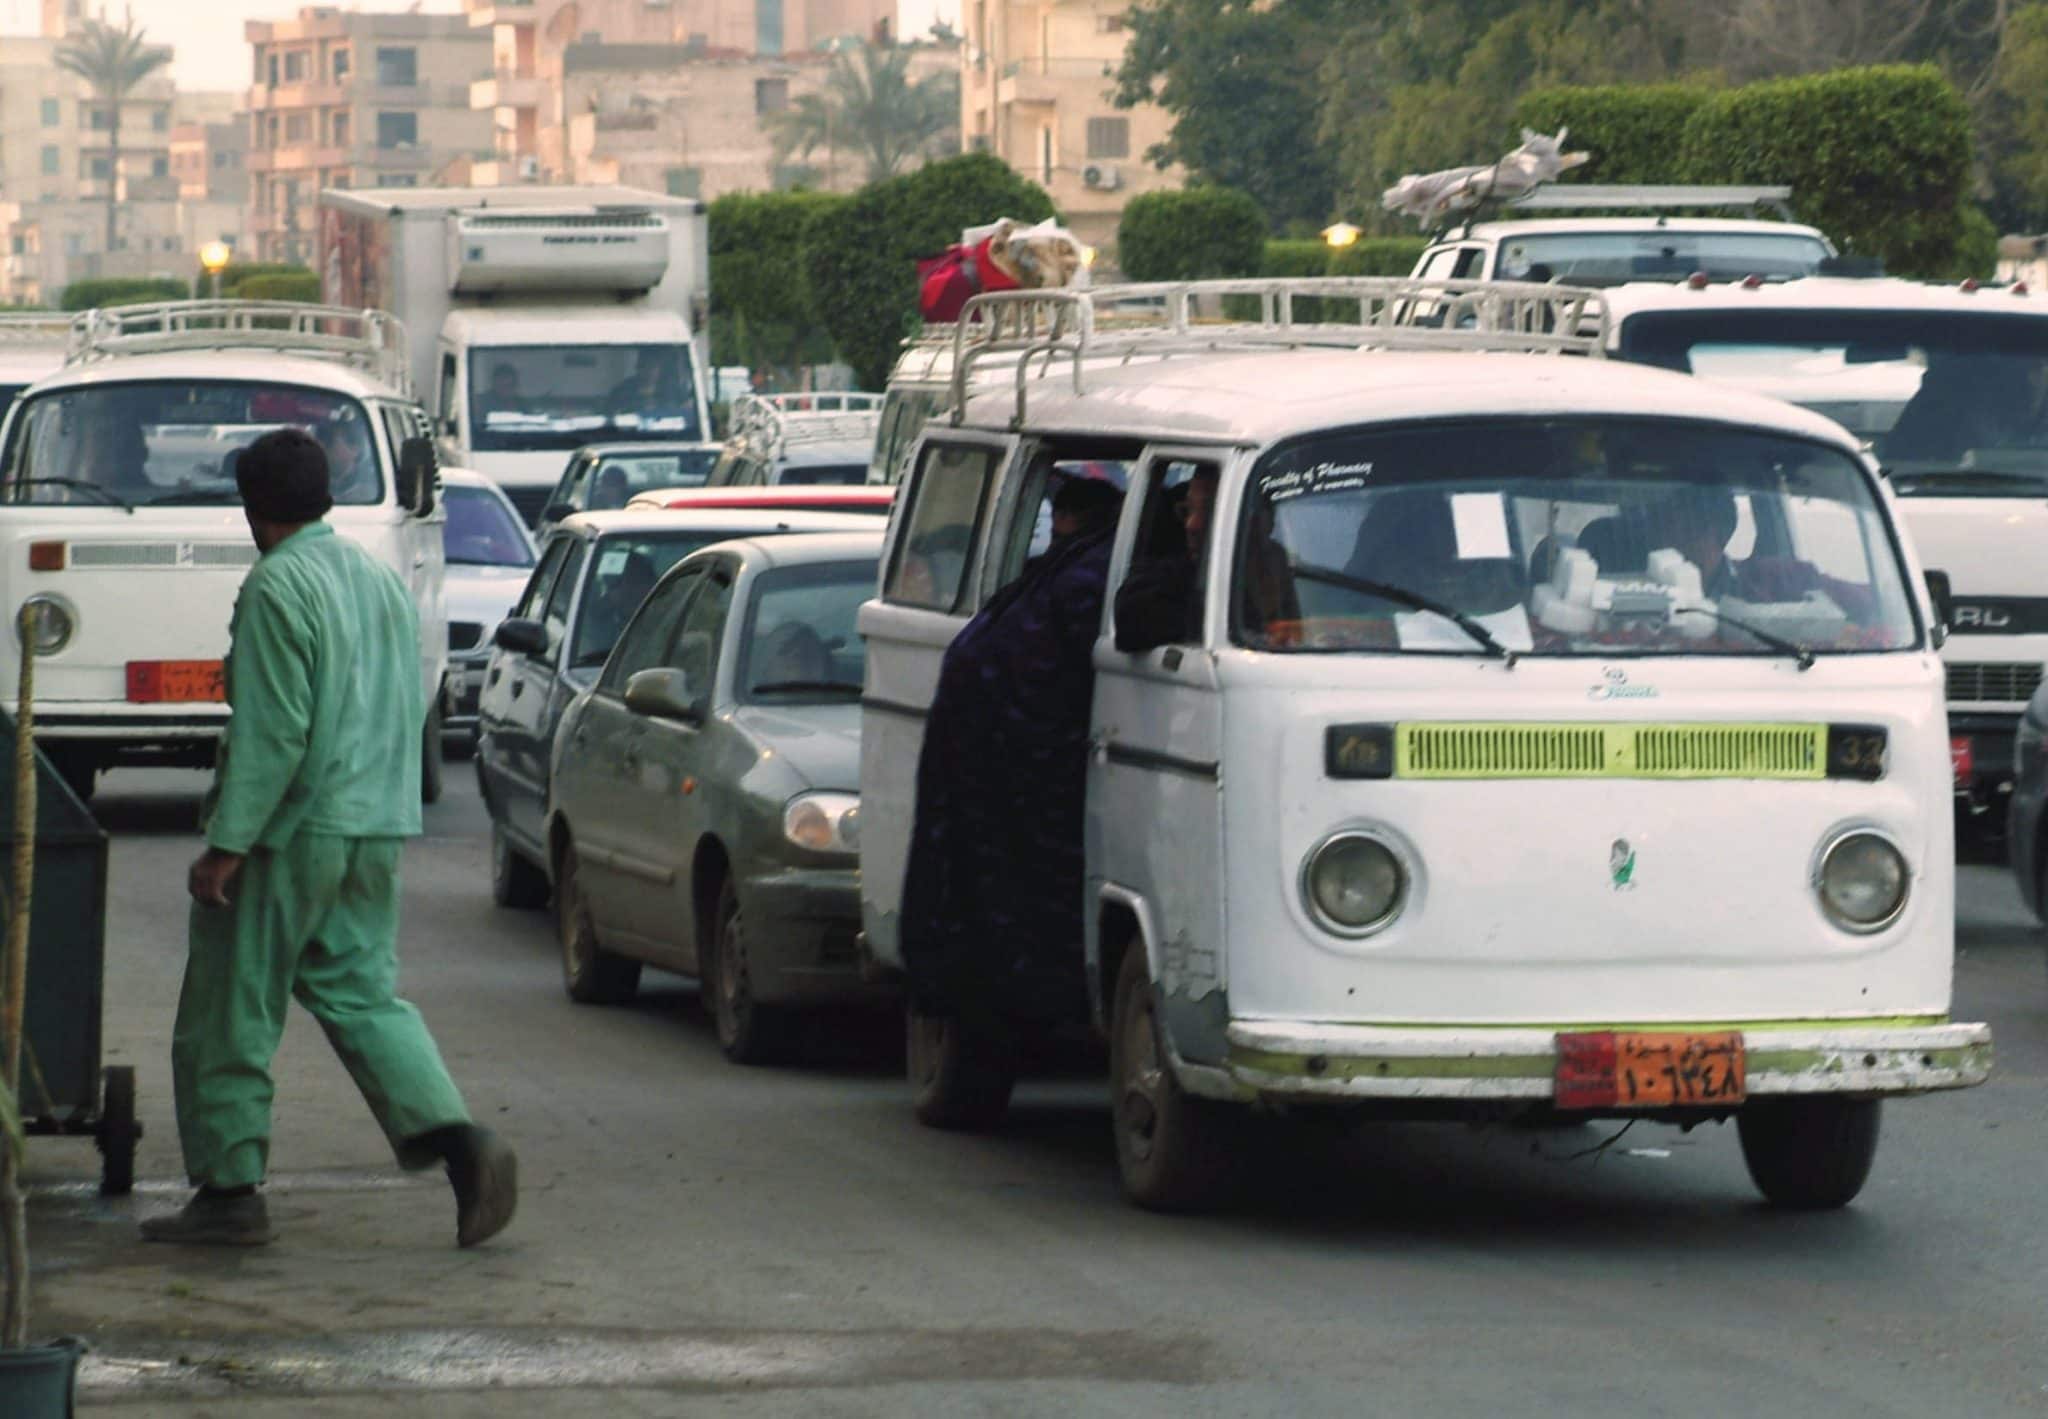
0, 715, 141, 1194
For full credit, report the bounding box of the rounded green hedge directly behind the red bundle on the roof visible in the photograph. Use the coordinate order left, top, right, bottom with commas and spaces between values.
802, 154, 1055, 389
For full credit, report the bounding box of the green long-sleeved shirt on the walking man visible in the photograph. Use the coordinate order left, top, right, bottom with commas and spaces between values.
205, 522, 426, 854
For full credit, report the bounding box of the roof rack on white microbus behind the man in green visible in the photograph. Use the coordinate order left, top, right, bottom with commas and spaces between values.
63, 301, 412, 397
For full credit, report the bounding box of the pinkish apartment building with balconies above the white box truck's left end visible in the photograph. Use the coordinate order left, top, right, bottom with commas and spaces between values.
246, 6, 492, 262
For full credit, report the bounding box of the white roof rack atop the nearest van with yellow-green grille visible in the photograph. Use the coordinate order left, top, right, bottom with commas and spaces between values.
950, 276, 1608, 426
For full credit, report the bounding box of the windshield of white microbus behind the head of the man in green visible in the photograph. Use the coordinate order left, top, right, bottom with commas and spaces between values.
0, 379, 383, 506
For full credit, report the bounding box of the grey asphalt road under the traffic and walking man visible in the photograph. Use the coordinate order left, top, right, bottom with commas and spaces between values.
19, 766, 2048, 1419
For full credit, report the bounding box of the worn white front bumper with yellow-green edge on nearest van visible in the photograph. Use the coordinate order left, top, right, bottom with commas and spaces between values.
1220, 1018, 1991, 1104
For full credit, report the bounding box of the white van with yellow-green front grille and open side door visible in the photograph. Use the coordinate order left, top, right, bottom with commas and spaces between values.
860, 281, 1991, 1208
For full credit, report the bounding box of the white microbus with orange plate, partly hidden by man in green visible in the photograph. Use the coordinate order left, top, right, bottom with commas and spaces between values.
0, 301, 449, 797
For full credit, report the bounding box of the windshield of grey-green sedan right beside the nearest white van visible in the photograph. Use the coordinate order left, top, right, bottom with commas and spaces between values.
735, 557, 877, 704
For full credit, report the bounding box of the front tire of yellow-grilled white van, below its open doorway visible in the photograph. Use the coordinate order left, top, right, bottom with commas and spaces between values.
1110, 944, 1237, 1212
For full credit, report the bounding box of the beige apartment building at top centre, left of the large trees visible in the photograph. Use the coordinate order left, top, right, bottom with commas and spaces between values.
961, 0, 1186, 252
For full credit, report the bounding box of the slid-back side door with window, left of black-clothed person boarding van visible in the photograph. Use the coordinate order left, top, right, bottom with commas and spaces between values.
860, 430, 1018, 964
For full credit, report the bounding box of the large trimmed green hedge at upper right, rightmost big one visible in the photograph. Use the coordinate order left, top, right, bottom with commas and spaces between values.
1675, 63, 1970, 276
